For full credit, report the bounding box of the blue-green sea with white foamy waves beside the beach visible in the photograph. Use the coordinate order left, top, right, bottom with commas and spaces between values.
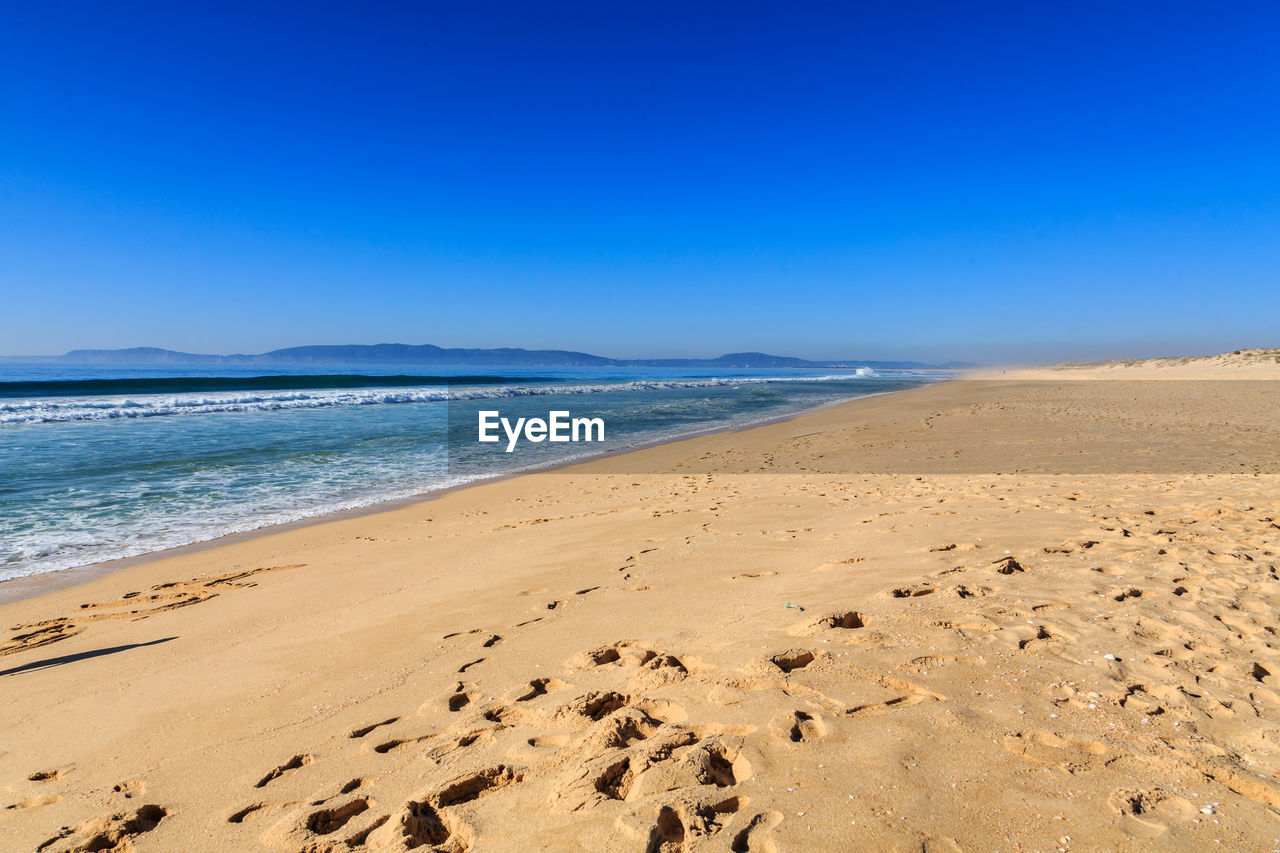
0, 364, 942, 580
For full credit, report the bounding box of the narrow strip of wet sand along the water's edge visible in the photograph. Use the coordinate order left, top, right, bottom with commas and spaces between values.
0, 381, 936, 605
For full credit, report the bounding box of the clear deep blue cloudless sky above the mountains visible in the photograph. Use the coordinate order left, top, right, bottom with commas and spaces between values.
0, 0, 1280, 361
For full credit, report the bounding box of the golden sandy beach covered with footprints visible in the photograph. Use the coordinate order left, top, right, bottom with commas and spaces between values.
0, 353, 1280, 852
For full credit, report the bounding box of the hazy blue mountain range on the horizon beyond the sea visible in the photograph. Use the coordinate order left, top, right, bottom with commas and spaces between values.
17, 343, 974, 370
